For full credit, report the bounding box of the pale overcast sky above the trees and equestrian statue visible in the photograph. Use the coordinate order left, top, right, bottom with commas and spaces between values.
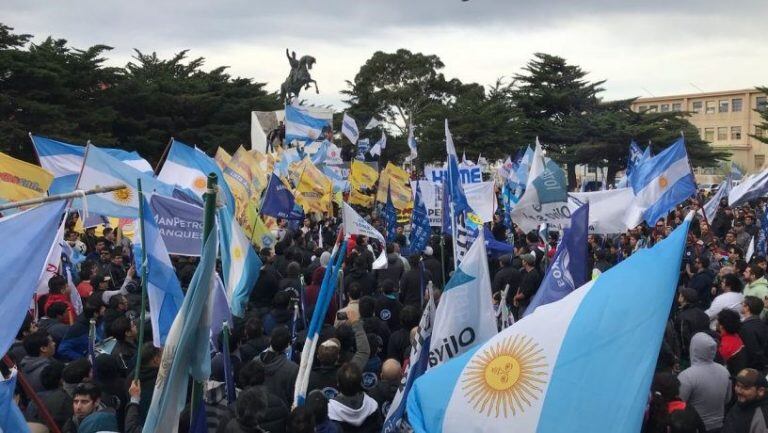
0, 0, 768, 109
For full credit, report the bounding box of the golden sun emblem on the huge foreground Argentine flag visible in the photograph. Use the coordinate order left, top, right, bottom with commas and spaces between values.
461, 335, 547, 418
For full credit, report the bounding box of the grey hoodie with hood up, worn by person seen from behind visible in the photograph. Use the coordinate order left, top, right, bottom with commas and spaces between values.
678, 332, 731, 431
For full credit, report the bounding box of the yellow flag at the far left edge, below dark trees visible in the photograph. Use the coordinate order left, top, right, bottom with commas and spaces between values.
0, 153, 53, 206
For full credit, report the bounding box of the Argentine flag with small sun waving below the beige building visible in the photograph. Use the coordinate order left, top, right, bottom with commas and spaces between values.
627, 138, 697, 225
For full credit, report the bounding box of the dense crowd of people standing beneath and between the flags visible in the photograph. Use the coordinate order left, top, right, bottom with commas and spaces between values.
2, 188, 768, 433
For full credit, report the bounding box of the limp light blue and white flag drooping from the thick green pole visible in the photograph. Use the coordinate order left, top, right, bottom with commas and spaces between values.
142, 226, 218, 433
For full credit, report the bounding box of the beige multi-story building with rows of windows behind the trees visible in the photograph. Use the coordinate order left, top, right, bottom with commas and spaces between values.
632, 89, 768, 172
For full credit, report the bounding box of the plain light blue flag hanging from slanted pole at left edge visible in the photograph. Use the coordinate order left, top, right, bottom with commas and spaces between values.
0, 201, 65, 353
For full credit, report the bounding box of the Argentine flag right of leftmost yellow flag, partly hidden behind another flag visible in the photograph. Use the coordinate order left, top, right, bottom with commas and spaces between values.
29, 134, 152, 194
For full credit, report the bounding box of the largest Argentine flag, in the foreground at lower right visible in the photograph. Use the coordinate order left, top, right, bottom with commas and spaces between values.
408, 217, 690, 433
